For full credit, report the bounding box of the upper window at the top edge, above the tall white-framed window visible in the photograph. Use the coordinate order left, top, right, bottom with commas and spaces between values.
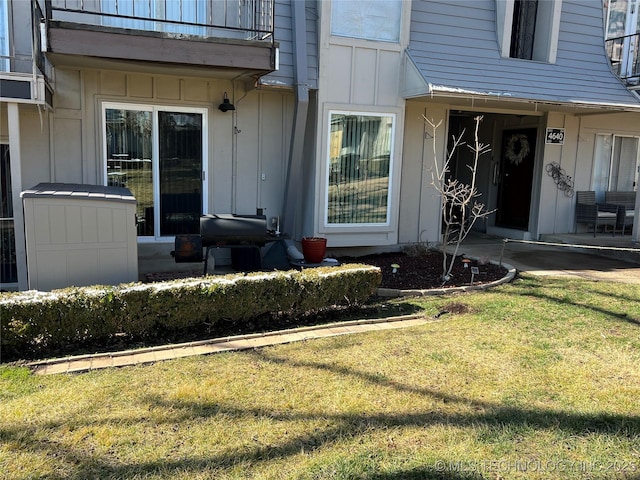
331, 0, 402, 42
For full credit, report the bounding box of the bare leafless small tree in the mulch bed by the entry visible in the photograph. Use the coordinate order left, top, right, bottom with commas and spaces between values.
422, 115, 495, 285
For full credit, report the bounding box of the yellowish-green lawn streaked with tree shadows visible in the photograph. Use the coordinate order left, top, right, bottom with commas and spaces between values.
0, 276, 640, 480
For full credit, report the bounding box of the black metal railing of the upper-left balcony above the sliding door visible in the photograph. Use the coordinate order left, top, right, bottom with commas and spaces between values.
38, 0, 274, 42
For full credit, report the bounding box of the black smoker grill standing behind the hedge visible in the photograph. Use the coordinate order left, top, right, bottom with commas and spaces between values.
174, 214, 282, 275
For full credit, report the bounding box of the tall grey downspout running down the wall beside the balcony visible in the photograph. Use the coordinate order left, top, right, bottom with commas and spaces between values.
281, 1, 309, 239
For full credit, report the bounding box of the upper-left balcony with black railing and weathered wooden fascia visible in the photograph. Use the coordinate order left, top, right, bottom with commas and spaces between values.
38, 0, 277, 75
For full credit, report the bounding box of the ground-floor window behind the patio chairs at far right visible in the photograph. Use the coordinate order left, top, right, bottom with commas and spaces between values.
592, 135, 640, 202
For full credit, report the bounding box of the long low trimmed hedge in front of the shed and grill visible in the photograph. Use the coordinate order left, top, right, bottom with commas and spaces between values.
0, 264, 382, 359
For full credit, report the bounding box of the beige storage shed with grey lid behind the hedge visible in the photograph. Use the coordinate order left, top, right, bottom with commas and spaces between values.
20, 183, 138, 291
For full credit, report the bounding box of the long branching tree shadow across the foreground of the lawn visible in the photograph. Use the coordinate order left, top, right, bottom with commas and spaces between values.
6, 351, 640, 480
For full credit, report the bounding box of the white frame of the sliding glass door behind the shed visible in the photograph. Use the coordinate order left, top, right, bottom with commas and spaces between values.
100, 101, 209, 243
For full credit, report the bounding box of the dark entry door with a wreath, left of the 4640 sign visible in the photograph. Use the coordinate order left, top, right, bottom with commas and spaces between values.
496, 128, 538, 230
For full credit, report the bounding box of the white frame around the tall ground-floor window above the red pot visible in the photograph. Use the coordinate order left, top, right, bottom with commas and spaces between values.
322, 109, 398, 233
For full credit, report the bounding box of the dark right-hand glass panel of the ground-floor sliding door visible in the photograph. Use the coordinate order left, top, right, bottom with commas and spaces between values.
158, 111, 202, 236
